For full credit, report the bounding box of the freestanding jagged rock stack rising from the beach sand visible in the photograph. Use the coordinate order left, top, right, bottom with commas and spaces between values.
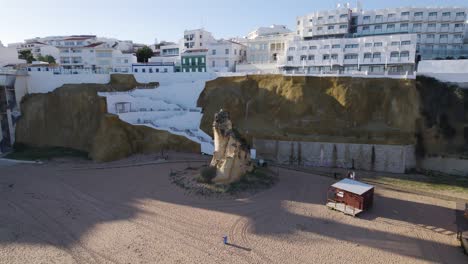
211, 110, 253, 184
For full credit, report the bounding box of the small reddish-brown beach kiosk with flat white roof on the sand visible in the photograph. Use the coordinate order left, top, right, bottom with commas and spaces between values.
327, 179, 374, 216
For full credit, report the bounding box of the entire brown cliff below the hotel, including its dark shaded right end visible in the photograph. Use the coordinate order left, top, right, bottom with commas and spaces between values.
198, 75, 468, 160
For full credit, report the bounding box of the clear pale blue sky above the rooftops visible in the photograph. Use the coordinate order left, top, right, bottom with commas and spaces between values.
0, 0, 468, 44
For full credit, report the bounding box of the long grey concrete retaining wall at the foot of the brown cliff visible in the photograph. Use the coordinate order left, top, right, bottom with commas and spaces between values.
254, 139, 416, 173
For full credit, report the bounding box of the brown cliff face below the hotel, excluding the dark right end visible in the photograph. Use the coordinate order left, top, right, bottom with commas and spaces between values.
198, 75, 420, 144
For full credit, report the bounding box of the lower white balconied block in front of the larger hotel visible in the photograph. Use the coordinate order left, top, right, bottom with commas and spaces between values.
282, 34, 417, 74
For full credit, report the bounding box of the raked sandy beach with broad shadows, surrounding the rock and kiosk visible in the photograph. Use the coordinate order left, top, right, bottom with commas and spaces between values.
0, 156, 468, 264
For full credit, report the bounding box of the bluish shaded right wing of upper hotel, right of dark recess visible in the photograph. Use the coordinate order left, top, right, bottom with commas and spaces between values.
355, 7, 468, 60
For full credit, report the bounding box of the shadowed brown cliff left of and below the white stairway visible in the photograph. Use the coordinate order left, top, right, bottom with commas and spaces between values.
16, 75, 200, 162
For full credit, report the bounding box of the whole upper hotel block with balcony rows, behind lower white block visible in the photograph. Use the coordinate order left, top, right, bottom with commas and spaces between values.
296, 5, 468, 60
